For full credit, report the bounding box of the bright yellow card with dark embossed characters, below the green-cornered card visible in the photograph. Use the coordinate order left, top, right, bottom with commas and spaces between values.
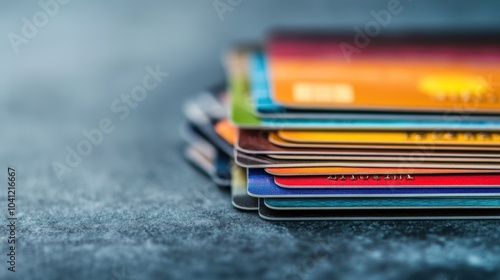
277, 130, 500, 146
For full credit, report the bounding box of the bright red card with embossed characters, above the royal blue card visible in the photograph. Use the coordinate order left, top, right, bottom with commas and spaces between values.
274, 174, 500, 188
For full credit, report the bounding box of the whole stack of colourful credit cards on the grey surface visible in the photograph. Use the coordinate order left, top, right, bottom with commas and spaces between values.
182, 34, 500, 220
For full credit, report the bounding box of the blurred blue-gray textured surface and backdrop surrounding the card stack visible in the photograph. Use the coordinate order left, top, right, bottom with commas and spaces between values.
0, 0, 500, 279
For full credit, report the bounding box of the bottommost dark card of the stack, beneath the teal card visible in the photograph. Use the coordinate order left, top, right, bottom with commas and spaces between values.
259, 198, 500, 221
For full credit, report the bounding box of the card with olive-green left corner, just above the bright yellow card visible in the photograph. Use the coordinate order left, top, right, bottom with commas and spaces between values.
226, 49, 500, 131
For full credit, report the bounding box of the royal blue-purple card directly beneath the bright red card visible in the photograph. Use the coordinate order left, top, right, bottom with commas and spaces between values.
247, 168, 500, 198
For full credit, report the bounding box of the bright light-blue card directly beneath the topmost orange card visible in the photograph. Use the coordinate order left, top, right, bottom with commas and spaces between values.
248, 51, 500, 123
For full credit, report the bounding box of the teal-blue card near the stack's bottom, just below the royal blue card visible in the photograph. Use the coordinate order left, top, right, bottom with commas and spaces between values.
264, 197, 500, 210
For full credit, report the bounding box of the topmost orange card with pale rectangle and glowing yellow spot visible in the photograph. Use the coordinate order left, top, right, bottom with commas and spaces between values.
268, 36, 500, 114
